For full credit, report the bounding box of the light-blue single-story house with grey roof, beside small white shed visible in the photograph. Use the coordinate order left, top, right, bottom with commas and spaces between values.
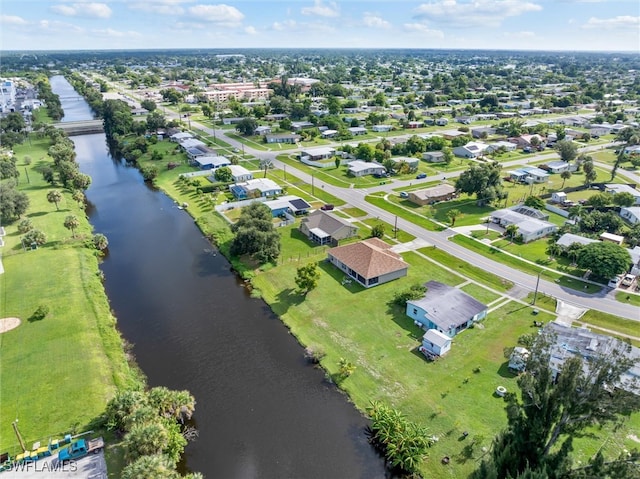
406, 281, 487, 338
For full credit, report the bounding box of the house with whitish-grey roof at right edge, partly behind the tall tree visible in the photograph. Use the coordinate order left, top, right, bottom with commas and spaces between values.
544, 321, 640, 394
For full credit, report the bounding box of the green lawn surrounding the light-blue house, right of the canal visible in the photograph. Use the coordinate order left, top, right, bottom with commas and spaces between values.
253, 249, 637, 477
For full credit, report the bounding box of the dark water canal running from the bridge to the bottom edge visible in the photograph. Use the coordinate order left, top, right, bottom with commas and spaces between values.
51, 76, 386, 479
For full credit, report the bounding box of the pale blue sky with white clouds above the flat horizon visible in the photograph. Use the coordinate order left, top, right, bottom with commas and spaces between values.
0, 0, 640, 54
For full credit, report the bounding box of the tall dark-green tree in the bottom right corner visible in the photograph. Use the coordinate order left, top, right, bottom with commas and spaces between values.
471, 329, 640, 479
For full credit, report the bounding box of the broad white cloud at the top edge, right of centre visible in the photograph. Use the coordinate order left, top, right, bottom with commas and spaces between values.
415, 0, 542, 27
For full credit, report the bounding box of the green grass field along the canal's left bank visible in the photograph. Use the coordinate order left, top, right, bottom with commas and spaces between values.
0, 138, 139, 452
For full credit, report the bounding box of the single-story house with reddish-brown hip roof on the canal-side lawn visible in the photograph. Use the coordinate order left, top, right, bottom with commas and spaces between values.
328, 238, 409, 288
